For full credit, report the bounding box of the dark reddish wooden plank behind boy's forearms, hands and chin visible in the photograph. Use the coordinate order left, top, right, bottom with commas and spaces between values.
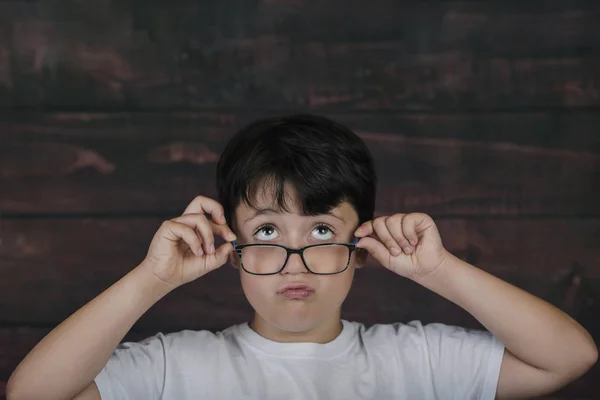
0, 218, 600, 333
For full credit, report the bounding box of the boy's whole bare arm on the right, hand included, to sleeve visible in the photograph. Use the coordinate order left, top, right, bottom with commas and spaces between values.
355, 213, 598, 398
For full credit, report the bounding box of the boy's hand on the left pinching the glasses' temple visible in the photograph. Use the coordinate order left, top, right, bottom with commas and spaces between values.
142, 196, 235, 289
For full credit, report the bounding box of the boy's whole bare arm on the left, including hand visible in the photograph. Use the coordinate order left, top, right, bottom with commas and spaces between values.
7, 196, 235, 400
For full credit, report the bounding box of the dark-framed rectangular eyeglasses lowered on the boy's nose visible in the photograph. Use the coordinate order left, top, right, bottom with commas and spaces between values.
232, 238, 360, 275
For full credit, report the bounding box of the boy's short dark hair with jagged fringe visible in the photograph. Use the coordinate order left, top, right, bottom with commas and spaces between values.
217, 115, 377, 230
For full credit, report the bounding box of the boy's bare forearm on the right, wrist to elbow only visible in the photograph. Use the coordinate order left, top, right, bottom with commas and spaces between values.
418, 254, 596, 373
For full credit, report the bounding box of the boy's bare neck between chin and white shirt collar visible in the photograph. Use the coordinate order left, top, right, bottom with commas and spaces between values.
250, 313, 343, 343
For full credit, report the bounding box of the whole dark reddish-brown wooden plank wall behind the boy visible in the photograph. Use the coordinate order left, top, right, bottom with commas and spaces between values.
0, 0, 600, 399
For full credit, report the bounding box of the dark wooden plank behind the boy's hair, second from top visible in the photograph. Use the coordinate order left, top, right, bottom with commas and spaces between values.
0, 111, 600, 216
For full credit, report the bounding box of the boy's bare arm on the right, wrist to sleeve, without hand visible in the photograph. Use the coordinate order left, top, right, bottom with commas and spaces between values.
416, 254, 598, 399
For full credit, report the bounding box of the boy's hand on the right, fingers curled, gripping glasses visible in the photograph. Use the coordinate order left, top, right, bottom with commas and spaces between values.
355, 213, 449, 280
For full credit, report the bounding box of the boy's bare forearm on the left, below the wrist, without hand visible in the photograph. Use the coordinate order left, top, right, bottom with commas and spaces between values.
7, 265, 169, 400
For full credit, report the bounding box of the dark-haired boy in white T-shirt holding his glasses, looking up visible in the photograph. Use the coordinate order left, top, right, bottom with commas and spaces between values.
8, 116, 597, 400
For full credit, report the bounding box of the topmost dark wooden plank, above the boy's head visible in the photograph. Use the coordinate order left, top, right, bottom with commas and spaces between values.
0, 0, 600, 110
